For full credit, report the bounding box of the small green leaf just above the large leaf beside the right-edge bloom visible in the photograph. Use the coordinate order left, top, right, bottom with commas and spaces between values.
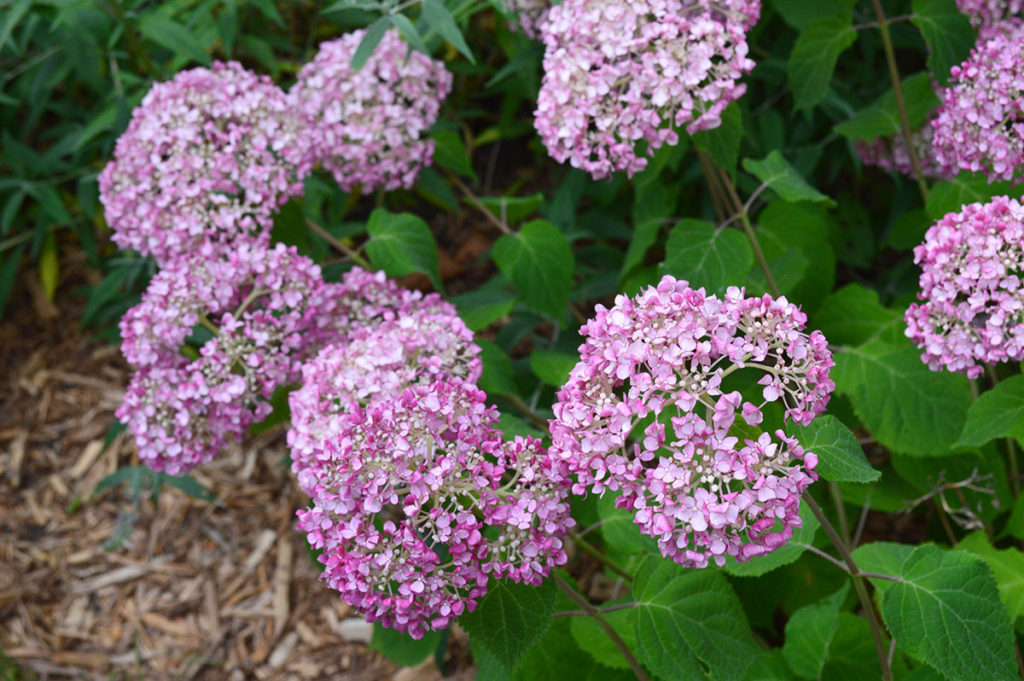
814, 284, 903, 345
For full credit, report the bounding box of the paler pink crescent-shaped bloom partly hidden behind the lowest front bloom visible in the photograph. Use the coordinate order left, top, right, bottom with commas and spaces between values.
288, 289, 482, 483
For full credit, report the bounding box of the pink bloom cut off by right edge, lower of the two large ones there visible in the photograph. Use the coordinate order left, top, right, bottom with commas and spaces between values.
906, 197, 1024, 378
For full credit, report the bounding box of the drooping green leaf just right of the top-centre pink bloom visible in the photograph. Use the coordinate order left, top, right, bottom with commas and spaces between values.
785, 14, 857, 110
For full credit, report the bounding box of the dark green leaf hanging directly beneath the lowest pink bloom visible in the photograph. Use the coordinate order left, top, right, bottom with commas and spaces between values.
459, 580, 555, 669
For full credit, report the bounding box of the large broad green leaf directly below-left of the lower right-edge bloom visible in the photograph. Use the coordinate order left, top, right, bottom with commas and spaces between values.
831, 341, 971, 457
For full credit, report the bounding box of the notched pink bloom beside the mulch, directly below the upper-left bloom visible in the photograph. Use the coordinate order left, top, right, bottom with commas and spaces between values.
117, 242, 344, 475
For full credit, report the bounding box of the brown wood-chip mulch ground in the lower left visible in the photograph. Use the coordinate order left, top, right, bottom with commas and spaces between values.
0, 251, 471, 681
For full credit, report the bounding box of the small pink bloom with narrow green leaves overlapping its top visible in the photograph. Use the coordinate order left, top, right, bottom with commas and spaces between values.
289, 30, 452, 193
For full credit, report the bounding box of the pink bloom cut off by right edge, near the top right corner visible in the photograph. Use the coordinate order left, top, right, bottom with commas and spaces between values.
933, 22, 1024, 183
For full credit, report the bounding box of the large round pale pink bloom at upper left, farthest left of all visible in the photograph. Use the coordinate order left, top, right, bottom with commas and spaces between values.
99, 61, 310, 264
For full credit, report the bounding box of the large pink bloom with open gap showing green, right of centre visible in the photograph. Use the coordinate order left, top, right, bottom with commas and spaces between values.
551, 276, 835, 567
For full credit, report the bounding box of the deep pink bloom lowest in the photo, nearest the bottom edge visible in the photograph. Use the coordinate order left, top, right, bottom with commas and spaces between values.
298, 379, 573, 638
